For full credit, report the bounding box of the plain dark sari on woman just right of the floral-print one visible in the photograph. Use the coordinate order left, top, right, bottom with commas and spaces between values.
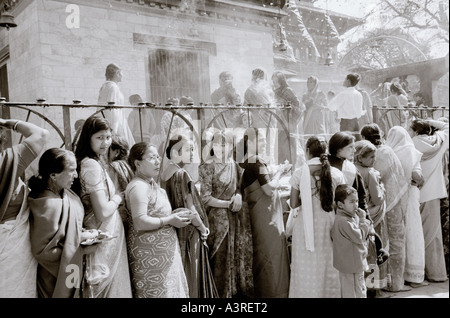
240, 157, 290, 298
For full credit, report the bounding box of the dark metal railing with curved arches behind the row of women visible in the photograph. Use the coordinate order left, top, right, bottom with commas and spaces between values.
0, 98, 449, 163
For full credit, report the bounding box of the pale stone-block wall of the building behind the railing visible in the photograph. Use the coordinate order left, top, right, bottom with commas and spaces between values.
2, 0, 274, 146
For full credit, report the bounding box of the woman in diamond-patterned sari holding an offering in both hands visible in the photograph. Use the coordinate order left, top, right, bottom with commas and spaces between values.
125, 142, 191, 298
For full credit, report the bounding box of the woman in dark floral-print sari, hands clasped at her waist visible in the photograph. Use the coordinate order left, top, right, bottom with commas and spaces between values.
199, 132, 254, 298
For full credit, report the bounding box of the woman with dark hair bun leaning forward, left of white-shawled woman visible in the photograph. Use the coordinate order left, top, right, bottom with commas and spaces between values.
361, 124, 411, 296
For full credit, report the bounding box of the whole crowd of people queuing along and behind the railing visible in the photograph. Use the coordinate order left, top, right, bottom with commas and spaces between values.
0, 65, 449, 299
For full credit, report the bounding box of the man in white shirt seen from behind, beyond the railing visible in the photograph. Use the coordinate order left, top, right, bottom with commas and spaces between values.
328, 74, 366, 137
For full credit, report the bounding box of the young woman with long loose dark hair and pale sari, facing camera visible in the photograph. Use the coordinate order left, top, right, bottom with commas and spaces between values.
74, 116, 131, 298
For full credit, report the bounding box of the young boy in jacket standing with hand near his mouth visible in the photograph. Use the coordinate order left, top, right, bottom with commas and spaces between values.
331, 184, 373, 298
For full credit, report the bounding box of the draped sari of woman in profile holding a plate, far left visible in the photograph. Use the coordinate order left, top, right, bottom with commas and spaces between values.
28, 189, 84, 298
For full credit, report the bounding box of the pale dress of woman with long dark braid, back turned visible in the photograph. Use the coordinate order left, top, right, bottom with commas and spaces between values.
289, 158, 345, 298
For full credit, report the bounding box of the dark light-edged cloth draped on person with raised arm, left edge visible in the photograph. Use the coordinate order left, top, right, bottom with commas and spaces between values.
0, 148, 19, 221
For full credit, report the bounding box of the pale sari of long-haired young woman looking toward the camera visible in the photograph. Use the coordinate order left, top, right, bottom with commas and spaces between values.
80, 158, 131, 298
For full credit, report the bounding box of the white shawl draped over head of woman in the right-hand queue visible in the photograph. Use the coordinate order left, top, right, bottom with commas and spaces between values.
386, 126, 422, 178
